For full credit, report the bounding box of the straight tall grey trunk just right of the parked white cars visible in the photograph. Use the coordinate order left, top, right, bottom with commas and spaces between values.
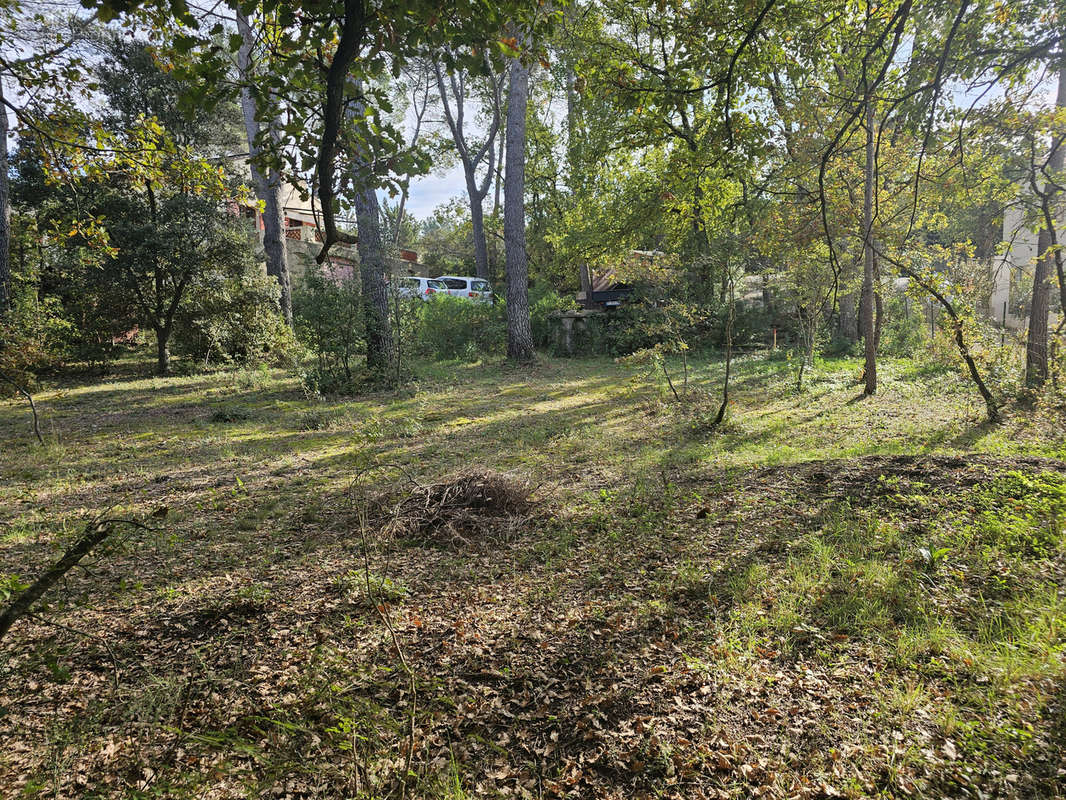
503, 59, 533, 362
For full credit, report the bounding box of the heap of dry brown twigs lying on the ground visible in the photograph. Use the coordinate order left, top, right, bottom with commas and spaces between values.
387, 469, 534, 545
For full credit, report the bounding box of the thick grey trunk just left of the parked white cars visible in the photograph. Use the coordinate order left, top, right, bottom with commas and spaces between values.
355, 186, 392, 377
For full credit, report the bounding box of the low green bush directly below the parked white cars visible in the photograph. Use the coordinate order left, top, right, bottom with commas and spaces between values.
413, 294, 507, 361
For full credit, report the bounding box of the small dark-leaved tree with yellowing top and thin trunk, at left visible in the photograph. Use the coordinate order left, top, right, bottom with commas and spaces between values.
26, 32, 255, 373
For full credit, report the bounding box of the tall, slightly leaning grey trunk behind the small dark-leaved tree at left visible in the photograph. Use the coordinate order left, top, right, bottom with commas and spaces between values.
237, 11, 292, 327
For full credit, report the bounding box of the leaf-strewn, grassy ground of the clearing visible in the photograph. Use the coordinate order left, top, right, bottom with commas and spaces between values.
0, 355, 1066, 800
